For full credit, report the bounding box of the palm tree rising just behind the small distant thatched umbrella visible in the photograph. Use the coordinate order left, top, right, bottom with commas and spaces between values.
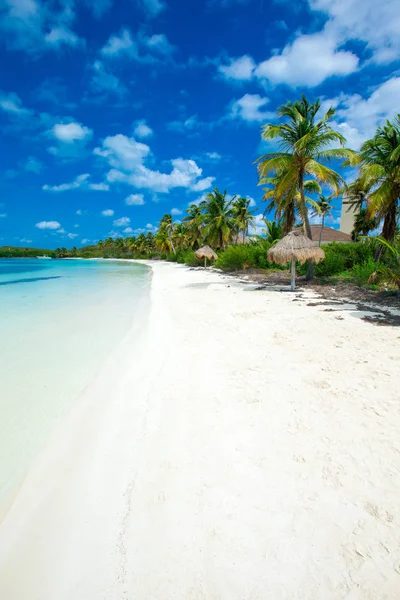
201, 188, 236, 250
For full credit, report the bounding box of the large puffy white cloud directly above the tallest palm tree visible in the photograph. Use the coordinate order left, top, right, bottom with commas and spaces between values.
254, 32, 358, 87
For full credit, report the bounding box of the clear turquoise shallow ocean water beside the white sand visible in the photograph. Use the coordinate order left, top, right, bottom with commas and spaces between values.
0, 259, 150, 517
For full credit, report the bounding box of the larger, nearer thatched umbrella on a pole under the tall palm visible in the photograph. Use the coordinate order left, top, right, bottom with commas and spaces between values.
268, 228, 325, 291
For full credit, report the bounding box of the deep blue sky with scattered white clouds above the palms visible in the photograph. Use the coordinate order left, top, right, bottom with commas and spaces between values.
0, 0, 400, 248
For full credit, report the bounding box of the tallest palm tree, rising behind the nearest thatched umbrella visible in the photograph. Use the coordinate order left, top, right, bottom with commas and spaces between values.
256, 95, 355, 279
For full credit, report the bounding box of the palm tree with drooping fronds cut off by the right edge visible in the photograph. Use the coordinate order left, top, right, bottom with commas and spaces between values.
358, 114, 400, 242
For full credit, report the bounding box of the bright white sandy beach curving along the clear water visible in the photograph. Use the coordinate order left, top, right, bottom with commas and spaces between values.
0, 264, 400, 600
